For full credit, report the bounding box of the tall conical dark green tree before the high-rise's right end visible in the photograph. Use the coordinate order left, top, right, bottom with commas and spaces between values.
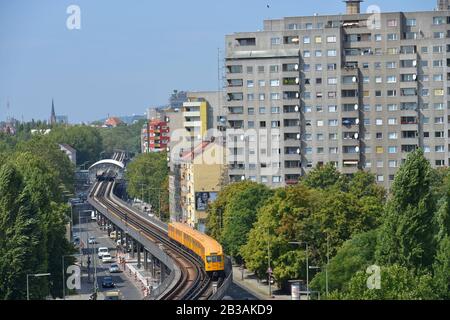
376, 149, 435, 269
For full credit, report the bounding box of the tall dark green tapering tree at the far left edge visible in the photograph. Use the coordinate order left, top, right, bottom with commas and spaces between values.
0, 164, 48, 300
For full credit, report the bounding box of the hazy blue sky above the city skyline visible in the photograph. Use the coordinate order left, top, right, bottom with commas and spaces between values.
0, 0, 436, 123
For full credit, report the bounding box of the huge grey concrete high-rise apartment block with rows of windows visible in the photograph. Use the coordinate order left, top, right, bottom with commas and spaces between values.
225, 0, 450, 187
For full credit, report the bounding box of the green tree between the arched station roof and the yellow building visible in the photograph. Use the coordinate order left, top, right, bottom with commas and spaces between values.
126, 152, 169, 217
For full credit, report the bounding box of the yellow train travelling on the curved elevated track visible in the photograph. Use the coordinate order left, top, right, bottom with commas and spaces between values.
169, 222, 225, 276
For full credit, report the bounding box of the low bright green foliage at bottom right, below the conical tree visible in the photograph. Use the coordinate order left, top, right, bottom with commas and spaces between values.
334, 264, 437, 300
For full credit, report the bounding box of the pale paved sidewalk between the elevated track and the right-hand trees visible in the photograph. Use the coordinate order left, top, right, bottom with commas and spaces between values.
233, 266, 291, 300
